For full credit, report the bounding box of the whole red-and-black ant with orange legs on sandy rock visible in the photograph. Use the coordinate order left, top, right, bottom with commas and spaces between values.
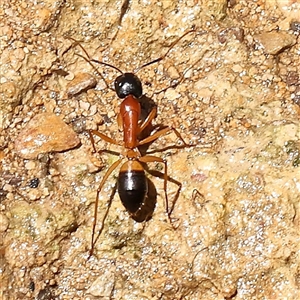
70, 28, 200, 257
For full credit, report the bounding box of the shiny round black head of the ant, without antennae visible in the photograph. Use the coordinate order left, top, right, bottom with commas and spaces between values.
115, 73, 143, 99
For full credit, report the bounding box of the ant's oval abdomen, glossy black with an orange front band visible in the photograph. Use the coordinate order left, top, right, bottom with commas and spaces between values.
118, 161, 148, 214
